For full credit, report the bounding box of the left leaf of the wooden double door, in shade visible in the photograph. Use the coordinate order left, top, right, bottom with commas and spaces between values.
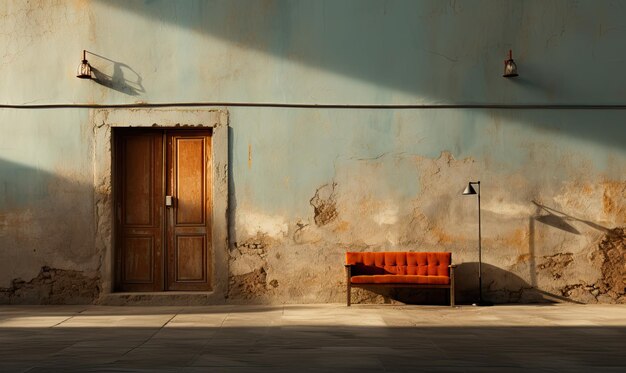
115, 130, 164, 291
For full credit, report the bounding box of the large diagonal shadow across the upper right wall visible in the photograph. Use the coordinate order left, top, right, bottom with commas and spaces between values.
98, 0, 626, 149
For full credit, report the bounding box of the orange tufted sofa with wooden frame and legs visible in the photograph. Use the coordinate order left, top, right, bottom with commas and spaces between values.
345, 252, 456, 306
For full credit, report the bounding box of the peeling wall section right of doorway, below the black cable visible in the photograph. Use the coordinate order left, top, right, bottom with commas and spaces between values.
231, 109, 626, 302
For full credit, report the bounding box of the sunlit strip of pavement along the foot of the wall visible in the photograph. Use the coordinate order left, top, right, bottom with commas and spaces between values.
0, 304, 626, 328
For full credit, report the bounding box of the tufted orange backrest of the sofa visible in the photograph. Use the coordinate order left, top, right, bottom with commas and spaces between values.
346, 252, 452, 276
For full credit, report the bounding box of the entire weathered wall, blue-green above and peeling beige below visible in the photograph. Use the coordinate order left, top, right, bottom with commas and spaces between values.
0, 0, 626, 303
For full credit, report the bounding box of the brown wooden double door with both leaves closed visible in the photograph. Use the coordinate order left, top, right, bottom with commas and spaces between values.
114, 128, 211, 291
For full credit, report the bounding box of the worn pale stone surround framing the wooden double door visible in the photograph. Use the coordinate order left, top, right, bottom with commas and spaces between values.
89, 107, 228, 305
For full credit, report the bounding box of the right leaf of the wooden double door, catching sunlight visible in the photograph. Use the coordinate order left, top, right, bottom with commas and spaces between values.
167, 131, 211, 290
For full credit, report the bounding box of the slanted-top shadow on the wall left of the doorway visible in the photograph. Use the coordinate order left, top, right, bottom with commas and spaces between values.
0, 159, 99, 304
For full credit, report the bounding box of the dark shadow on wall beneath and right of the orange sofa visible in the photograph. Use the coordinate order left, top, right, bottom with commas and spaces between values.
353, 262, 579, 305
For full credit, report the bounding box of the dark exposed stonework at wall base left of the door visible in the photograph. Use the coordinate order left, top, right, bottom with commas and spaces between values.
0, 266, 100, 304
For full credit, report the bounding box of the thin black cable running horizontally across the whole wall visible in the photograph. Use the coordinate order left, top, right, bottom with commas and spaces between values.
0, 102, 626, 110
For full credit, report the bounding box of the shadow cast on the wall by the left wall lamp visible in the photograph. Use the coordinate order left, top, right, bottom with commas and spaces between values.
87, 52, 146, 96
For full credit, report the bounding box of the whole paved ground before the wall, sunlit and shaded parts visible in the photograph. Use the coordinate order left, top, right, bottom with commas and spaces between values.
0, 304, 626, 372
